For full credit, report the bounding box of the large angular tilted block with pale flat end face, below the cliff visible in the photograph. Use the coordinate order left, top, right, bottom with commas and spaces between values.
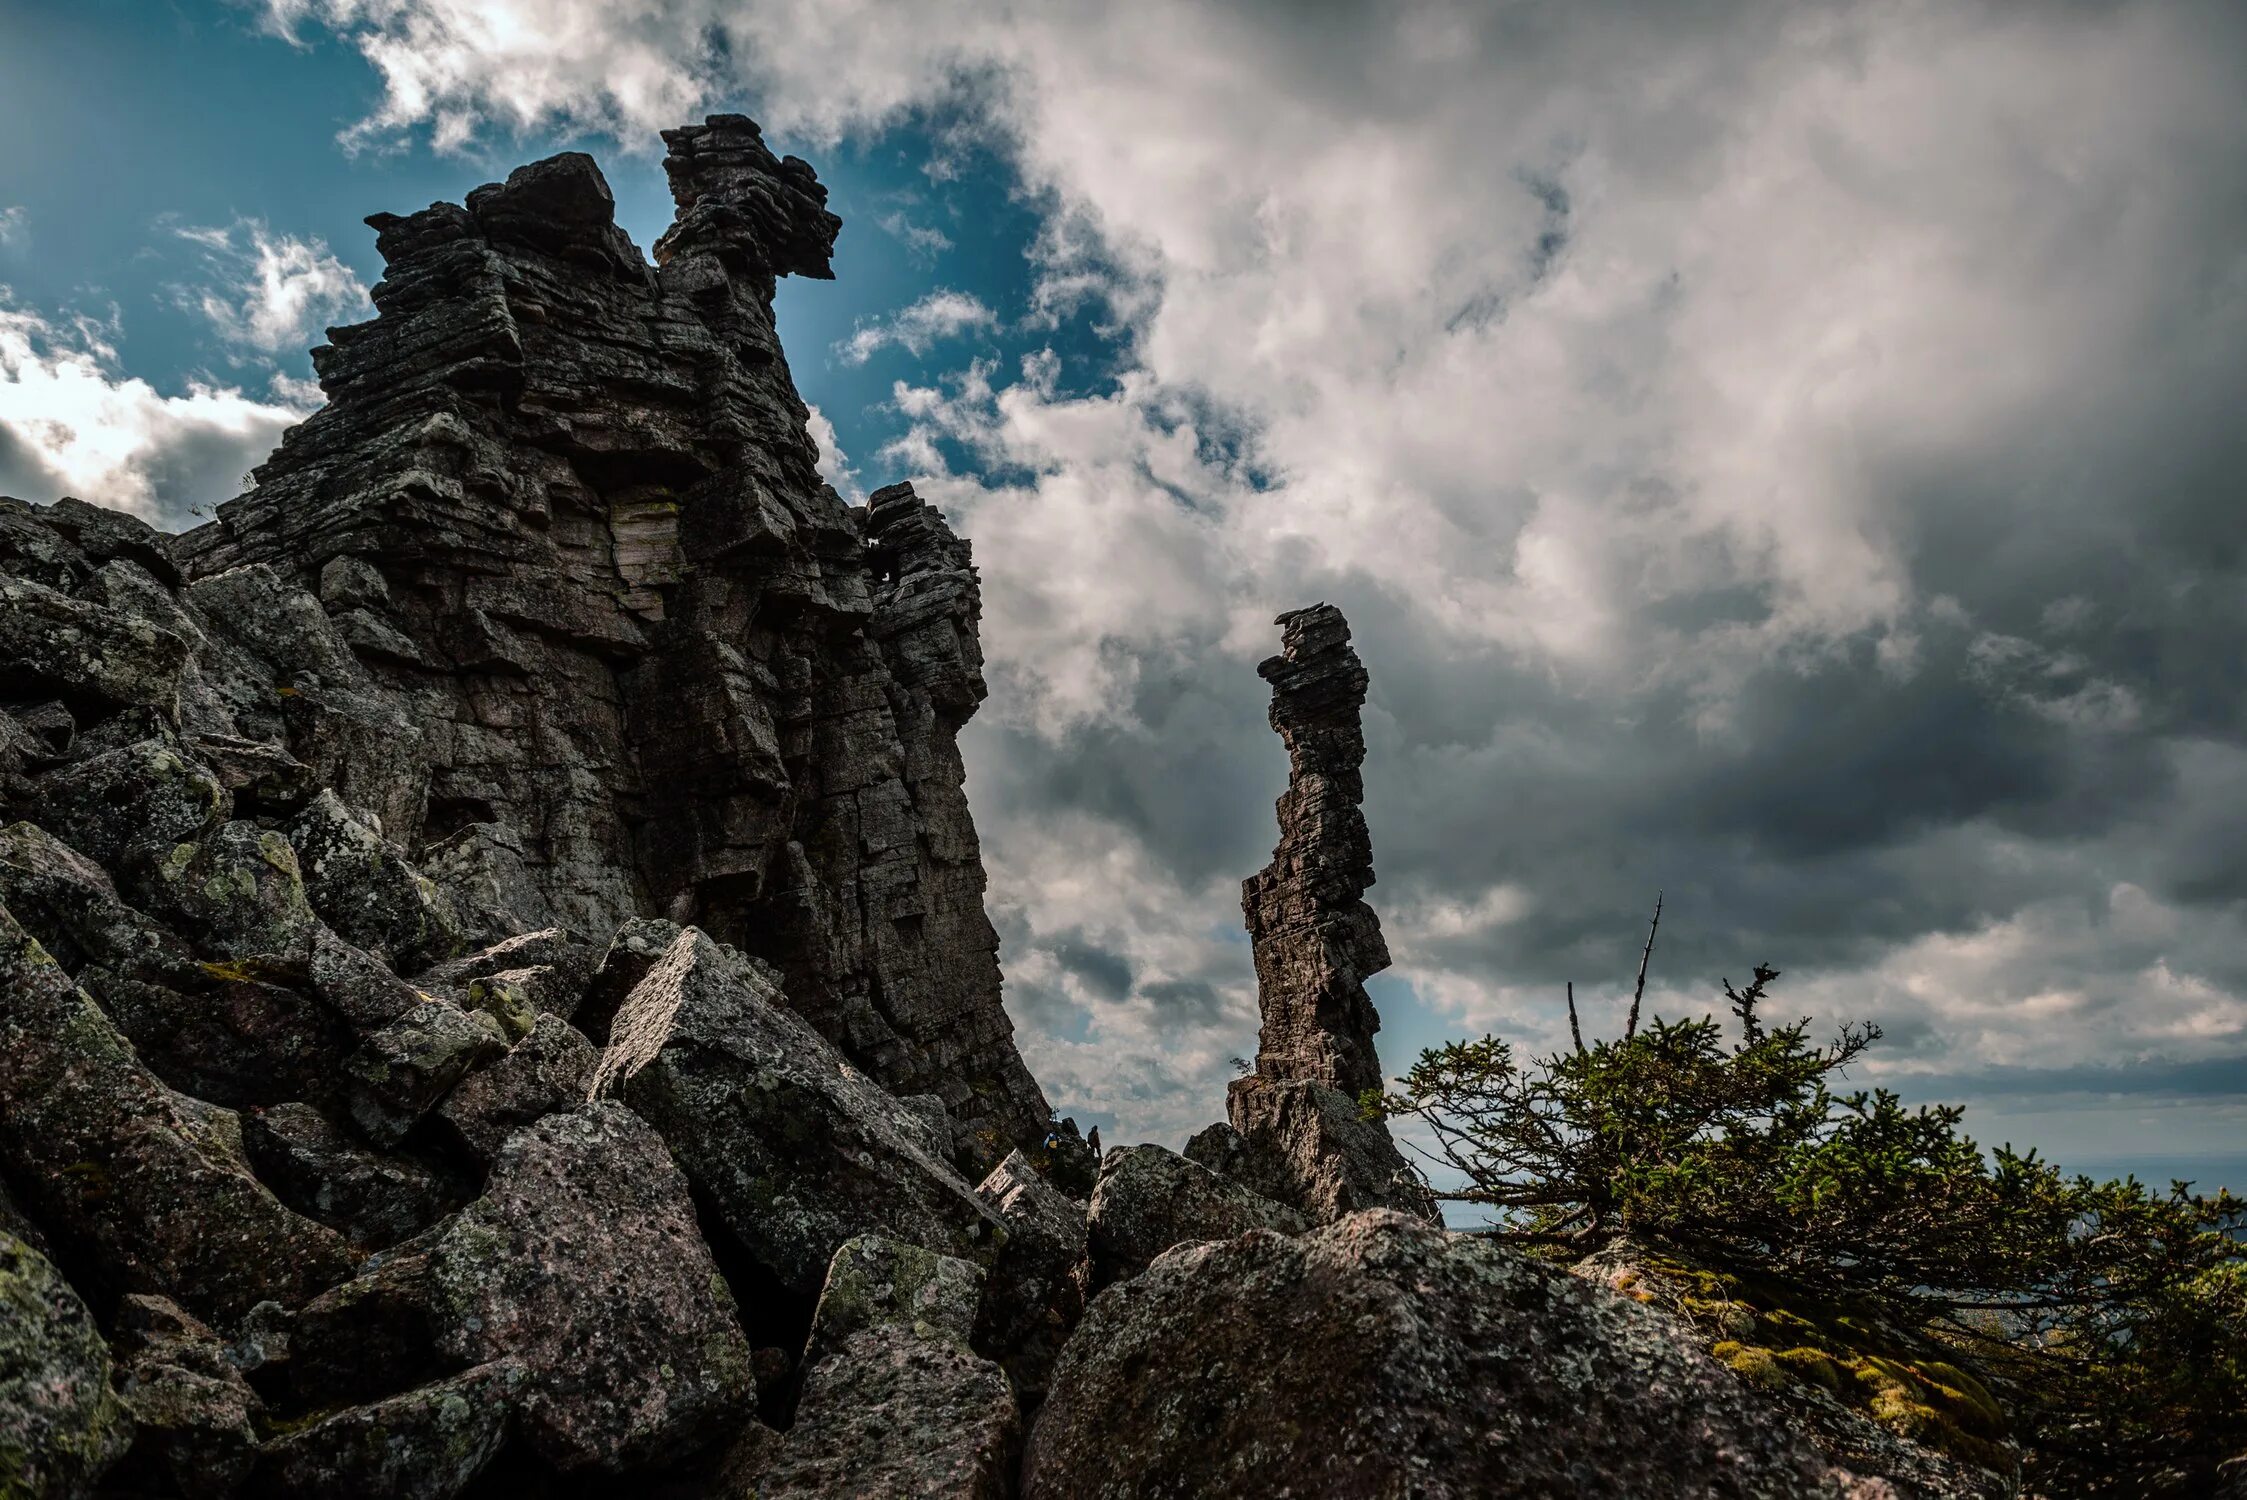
595, 927, 1004, 1298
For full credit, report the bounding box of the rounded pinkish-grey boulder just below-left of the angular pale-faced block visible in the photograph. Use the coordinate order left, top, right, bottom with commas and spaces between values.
429, 1103, 755, 1473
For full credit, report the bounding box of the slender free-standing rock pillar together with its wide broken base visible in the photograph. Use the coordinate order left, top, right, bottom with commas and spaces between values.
1222, 604, 1434, 1222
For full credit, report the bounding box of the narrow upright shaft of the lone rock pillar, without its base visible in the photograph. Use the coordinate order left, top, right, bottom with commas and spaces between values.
1240, 604, 1389, 1098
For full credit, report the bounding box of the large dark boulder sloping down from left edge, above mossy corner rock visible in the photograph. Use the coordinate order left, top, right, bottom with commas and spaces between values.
0, 909, 351, 1318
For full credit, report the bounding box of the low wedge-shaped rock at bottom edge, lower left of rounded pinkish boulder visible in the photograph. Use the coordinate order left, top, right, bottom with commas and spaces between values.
252, 1361, 526, 1500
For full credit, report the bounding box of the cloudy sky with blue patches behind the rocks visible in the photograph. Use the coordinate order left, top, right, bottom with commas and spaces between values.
0, 0, 2247, 1186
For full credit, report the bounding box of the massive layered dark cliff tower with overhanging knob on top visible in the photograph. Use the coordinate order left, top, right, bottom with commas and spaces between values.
180, 115, 1049, 1170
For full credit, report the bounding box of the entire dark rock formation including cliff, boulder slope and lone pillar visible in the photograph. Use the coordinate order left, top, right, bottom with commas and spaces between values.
0, 117, 2022, 1500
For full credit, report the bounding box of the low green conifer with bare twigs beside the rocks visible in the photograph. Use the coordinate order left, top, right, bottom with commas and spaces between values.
1364, 907, 2247, 1496
